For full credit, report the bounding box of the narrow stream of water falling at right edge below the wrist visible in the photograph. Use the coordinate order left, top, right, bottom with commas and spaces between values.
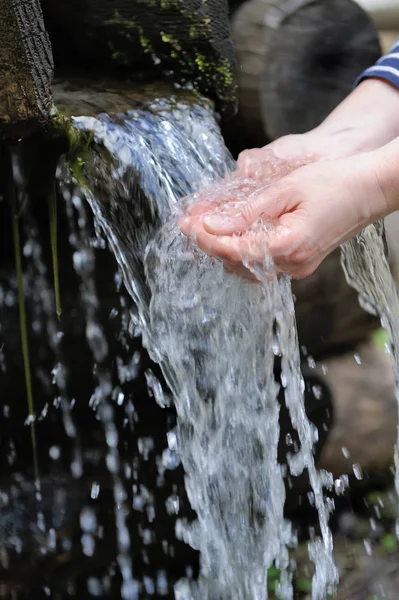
341, 222, 399, 536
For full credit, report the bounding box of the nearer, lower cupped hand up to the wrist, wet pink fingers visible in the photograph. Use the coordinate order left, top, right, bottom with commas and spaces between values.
180, 153, 389, 278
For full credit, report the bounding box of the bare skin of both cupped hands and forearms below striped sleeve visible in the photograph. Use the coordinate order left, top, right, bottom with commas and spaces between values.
179, 79, 399, 279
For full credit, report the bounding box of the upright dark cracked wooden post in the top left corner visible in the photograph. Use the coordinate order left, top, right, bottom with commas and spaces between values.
0, 0, 53, 135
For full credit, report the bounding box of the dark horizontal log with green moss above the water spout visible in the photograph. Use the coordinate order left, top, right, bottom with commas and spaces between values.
42, 0, 236, 115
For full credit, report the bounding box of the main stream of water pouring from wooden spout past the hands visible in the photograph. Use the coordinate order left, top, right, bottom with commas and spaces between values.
74, 96, 337, 600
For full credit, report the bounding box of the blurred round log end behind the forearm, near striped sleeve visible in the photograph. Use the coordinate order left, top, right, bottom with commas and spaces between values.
232, 0, 381, 140
